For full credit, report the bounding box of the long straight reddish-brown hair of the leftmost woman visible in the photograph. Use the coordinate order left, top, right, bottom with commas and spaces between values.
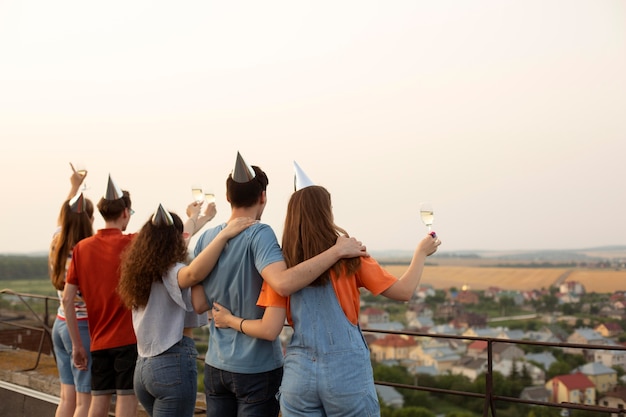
48, 198, 93, 290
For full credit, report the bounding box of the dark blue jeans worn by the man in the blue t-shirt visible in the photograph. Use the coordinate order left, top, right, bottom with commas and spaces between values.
204, 364, 283, 417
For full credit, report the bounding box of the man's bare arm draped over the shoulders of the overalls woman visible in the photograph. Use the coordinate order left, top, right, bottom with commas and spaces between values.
261, 236, 369, 297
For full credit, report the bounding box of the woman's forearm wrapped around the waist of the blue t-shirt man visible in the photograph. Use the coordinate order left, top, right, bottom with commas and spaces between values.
212, 301, 287, 341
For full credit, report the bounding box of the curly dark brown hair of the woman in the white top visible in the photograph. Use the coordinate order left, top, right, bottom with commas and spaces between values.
117, 213, 188, 308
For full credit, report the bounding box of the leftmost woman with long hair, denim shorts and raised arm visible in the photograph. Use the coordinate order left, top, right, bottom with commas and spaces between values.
48, 164, 94, 417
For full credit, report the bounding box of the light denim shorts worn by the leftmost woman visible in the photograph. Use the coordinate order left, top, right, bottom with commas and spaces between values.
52, 317, 91, 393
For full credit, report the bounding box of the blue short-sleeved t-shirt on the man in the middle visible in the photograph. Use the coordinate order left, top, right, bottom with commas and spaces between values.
194, 223, 284, 374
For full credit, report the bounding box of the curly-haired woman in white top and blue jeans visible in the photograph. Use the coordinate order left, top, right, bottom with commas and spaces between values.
117, 205, 255, 417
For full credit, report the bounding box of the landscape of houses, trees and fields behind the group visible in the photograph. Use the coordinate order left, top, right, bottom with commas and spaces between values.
0, 247, 626, 417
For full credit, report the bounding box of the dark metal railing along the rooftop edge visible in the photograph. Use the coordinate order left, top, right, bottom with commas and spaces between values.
0, 289, 626, 417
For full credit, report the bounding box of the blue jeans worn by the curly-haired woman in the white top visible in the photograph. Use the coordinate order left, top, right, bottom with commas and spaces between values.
134, 336, 198, 417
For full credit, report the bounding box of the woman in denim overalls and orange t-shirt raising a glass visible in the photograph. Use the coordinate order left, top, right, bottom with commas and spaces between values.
213, 177, 441, 417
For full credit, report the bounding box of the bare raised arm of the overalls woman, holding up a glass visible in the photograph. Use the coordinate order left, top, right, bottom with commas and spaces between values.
382, 234, 441, 301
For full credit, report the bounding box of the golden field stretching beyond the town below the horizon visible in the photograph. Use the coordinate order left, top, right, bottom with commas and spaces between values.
384, 265, 626, 293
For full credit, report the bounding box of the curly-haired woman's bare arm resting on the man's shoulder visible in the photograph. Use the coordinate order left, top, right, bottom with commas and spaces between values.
178, 217, 257, 288
